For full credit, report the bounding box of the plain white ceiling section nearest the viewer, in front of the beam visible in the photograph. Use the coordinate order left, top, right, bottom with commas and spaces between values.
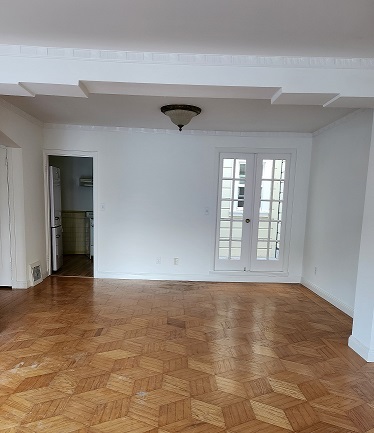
0, 0, 374, 58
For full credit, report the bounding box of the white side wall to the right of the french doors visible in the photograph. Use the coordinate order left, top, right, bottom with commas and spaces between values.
302, 110, 373, 316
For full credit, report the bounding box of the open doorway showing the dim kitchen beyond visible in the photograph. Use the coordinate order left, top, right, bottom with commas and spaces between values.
48, 155, 94, 277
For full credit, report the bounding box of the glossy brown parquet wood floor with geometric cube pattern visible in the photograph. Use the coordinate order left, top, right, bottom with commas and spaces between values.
0, 277, 374, 433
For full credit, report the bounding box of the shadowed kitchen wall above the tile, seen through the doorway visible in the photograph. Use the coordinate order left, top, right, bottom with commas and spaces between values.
49, 156, 93, 211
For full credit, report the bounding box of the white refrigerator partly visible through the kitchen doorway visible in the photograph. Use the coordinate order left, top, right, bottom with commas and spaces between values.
49, 166, 63, 271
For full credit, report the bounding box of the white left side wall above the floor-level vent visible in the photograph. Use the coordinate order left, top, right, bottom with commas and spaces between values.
0, 102, 46, 288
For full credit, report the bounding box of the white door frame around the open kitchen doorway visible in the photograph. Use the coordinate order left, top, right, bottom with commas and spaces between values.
43, 149, 99, 277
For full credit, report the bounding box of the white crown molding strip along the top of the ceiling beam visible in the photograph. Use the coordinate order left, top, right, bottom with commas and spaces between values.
0, 44, 374, 69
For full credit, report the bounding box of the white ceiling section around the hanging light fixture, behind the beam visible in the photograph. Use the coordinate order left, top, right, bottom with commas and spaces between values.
4, 94, 352, 132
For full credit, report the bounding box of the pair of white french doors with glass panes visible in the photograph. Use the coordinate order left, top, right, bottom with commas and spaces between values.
215, 153, 291, 271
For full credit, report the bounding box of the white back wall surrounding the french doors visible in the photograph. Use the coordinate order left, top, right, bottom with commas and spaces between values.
44, 126, 311, 282
